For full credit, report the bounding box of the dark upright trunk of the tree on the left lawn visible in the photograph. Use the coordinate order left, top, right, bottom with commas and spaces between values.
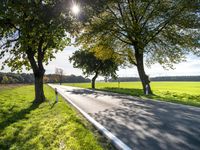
34, 70, 45, 103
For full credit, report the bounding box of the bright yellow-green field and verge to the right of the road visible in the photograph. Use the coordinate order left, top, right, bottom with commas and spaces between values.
65, 82, 200, 107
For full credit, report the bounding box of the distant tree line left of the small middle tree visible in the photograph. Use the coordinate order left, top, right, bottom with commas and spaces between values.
0, 72, 90, 84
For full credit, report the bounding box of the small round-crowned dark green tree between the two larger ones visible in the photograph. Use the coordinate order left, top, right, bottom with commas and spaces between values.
69, 50, 119, 89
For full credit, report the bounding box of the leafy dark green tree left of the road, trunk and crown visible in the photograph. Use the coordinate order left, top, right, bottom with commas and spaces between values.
0, 0, 74, 103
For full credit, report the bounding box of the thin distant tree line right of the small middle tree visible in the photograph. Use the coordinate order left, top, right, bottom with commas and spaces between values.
109, 76, 200, 82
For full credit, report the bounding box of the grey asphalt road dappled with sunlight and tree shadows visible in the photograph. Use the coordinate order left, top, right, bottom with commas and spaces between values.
49, 85, 200, 150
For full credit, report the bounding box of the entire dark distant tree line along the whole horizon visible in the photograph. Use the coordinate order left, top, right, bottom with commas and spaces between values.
0, 72, 200, 84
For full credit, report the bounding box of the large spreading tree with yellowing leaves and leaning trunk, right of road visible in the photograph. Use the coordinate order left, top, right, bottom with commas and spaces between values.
79, 0, 200, 93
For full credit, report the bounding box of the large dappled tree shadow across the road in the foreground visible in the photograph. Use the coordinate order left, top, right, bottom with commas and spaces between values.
93, 100, 200, 150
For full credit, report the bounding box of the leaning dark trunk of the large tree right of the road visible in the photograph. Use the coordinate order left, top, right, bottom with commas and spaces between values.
135, 48, 152, 94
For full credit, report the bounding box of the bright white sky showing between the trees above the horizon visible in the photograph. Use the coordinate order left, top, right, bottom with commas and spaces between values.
0, 46, 200, 77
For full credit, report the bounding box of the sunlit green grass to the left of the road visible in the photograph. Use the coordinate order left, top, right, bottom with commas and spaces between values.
0, 85, 109, 150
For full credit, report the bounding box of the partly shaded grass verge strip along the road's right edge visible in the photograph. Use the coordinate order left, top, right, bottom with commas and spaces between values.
100, 87, 200, 107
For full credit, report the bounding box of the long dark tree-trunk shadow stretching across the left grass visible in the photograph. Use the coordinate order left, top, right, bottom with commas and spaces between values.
0, 103, 40, 131
